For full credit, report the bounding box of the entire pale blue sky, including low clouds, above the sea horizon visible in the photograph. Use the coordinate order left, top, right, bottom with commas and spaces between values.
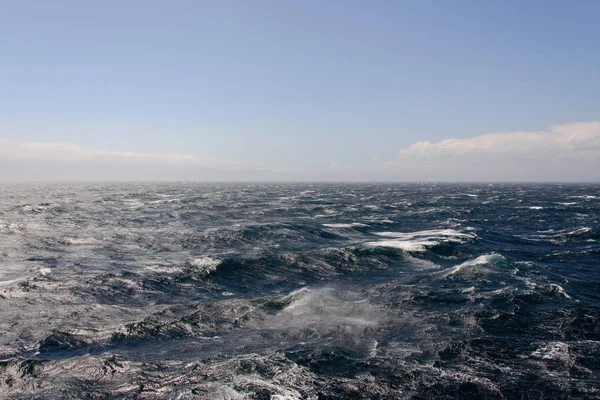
0, 0, 600, 181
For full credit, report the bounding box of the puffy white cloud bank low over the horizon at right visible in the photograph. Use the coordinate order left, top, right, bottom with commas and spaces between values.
382, 121, 600, 181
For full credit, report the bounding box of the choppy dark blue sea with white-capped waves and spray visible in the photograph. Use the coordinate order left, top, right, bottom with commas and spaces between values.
0, 184, 600, 399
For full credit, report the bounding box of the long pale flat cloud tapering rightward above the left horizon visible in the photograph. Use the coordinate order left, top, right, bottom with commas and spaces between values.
0, 139, 284, 181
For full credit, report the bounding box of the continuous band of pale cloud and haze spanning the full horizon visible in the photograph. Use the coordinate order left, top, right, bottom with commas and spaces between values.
0, 121, 600, 181
